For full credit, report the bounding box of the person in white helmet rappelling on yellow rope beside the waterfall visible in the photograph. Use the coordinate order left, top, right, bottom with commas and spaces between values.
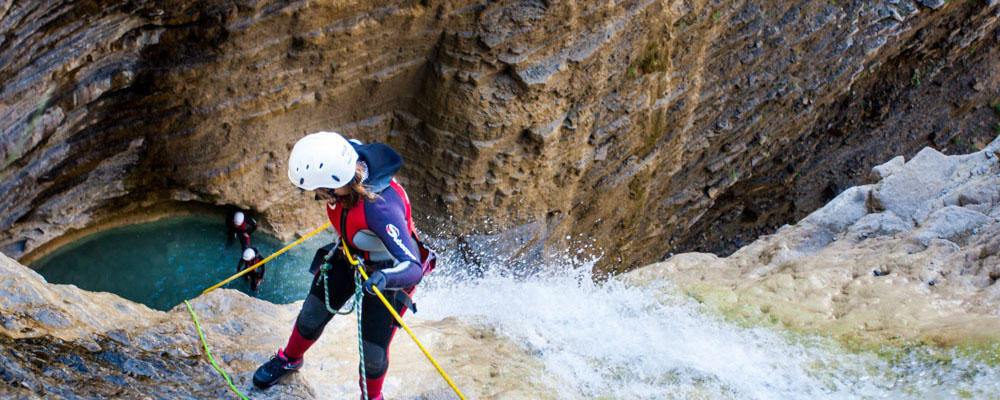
253, 132, 435, 400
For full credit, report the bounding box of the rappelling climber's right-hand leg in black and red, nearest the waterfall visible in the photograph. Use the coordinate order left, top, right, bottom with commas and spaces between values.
358, 288, 413, 400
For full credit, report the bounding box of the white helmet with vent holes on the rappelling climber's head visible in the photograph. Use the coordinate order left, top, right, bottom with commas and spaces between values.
288, 132, 358, 190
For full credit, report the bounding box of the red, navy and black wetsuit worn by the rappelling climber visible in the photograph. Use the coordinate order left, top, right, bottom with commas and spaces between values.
283, 143, 426, 399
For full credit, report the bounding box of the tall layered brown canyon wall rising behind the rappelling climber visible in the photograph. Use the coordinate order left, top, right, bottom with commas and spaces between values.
0, 0, 1000, 269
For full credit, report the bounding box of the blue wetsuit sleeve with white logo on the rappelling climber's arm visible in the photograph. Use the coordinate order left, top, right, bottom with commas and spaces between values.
365, 189, 424, 290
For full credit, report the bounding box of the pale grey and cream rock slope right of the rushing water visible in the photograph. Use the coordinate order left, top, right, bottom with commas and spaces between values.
630, 135, 1000, 346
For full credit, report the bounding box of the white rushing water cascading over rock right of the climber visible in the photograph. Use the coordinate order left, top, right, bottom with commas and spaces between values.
420, 248, 1000, 399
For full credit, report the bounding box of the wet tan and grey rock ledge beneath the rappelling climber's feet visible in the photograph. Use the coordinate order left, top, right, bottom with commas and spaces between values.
0, 255, 551, 400
